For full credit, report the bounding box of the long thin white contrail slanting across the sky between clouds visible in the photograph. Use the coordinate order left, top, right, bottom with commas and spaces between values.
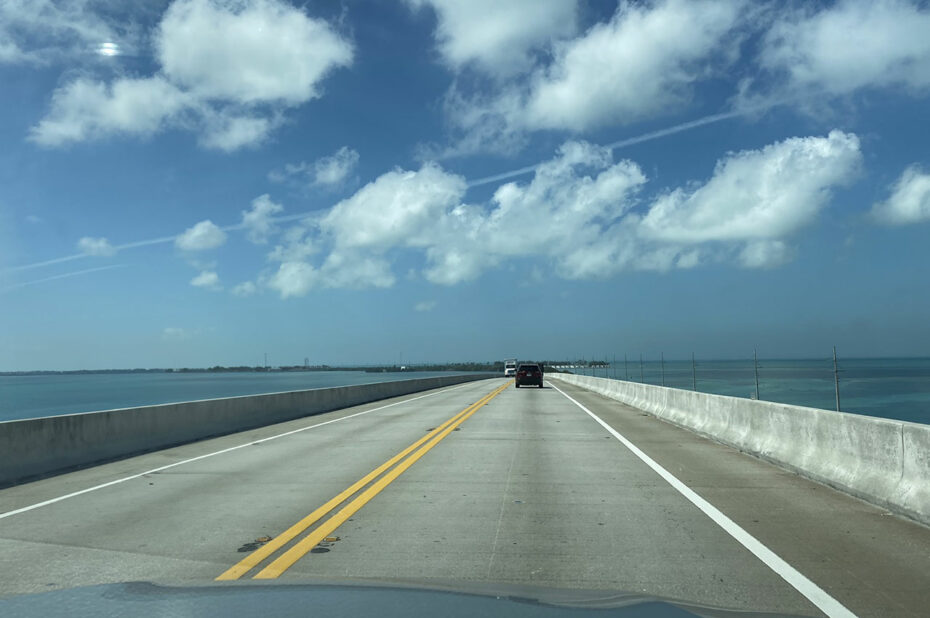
2, 101, 764, 274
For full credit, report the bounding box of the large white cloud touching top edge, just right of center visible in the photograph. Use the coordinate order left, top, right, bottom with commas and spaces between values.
524, 0, 742, 131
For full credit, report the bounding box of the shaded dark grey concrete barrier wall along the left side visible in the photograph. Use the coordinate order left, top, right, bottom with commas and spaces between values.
0, 374, 499, 486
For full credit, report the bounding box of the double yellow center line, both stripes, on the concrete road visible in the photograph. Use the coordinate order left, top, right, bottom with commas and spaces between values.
216, 381, 510, 581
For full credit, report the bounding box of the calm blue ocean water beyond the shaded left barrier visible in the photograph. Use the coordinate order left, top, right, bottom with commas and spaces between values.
0, 371, 472, 421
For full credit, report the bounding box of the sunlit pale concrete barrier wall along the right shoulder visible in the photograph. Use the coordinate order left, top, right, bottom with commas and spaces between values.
548, 374, 930, 525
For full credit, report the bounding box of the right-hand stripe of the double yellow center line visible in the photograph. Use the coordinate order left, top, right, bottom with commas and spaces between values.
255, 383, 509, 579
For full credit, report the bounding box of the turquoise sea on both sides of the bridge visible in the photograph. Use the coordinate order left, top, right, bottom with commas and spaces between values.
0, 357, 930, 423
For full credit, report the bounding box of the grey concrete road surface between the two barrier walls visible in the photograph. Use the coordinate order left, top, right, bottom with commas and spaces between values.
0, 380, 930, 616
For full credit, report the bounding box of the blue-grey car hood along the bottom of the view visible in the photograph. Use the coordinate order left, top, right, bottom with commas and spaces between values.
0, 580, 804, 618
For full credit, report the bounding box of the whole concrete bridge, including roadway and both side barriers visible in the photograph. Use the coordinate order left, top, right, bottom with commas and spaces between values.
0, 374, 930, 616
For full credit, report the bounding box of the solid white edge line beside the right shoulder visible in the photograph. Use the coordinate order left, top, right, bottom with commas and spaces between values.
549, 382, 856, 618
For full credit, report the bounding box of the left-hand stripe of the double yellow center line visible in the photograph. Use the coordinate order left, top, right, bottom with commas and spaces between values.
216, 378, 506, 581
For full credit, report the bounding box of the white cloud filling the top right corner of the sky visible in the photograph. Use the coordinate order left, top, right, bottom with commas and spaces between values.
759, 0, 930, 95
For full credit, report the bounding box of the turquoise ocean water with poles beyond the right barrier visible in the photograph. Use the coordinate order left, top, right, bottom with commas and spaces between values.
572, 357, 930, 423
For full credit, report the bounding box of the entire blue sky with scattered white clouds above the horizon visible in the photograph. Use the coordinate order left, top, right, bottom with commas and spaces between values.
0, 0, 930, 371
